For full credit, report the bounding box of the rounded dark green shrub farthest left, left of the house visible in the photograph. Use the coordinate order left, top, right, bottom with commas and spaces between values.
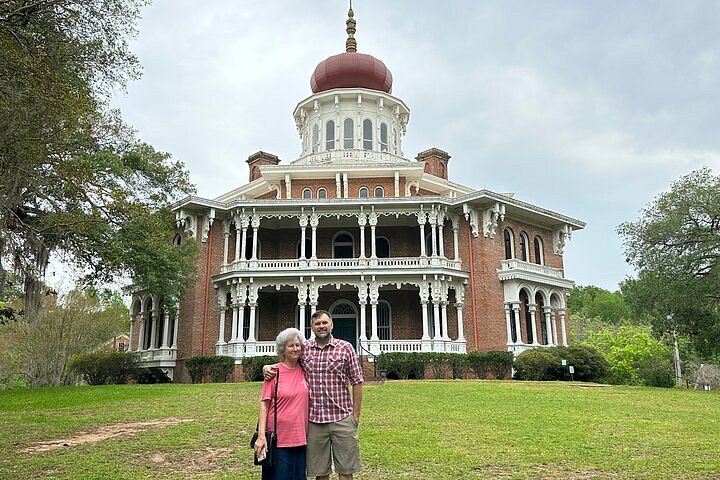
67, 351, 138, 385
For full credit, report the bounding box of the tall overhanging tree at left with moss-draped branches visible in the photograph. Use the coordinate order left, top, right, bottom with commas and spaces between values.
0, 0, 195, 321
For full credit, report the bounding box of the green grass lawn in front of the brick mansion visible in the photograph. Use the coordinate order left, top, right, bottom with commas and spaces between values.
0, 381, 720, 479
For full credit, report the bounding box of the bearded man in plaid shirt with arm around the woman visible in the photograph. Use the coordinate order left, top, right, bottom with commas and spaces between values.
263, 310, 363, 480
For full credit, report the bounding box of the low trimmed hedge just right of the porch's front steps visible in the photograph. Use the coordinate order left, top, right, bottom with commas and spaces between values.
376, 351, 513, 379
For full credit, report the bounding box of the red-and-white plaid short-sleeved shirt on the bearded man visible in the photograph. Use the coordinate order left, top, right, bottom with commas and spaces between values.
302, 337, 363, 423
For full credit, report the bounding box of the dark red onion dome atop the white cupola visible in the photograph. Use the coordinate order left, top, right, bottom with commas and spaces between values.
310, 52, 392, 93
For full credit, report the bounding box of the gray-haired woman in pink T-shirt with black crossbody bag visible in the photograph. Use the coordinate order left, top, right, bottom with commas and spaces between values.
255, 328, 308, 480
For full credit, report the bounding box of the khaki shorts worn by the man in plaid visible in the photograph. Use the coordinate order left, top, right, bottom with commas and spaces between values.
307, 415, 362, 477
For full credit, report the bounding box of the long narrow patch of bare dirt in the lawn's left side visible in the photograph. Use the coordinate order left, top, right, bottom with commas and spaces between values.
20, 418, 192, 453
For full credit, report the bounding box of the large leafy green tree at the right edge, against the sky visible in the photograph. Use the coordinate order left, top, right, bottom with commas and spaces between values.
618, 168, 720, 356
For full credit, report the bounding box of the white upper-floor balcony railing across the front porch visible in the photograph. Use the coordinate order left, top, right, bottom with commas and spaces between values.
220, 257, 461, 273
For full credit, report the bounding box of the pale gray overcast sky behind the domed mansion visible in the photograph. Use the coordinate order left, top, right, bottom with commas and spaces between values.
109, 0, 720, 290
